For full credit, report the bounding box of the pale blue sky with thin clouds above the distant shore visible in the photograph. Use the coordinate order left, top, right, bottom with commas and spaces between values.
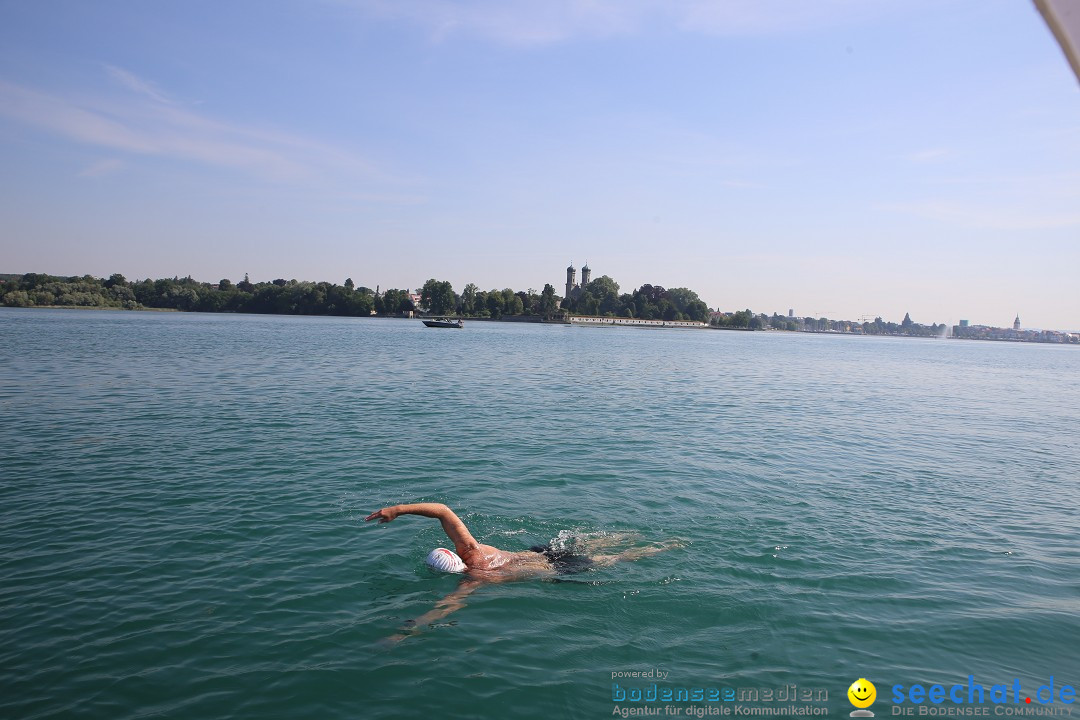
0, 0, 1080, 330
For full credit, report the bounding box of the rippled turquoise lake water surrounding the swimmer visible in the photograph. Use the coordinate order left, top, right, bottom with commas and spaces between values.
0, 310, 1080, 719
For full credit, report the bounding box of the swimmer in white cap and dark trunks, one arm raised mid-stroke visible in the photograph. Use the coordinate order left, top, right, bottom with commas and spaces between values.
365, 503, 683, 646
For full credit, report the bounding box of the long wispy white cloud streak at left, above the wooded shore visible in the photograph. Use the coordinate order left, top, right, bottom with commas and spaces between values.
0, 66, 387, 181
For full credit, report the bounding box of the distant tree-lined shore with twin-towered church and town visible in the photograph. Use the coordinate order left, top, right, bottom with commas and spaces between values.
6, 274, 1080, 344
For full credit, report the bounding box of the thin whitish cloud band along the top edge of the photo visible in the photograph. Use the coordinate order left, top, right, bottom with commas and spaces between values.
328, 0, 913, 45
